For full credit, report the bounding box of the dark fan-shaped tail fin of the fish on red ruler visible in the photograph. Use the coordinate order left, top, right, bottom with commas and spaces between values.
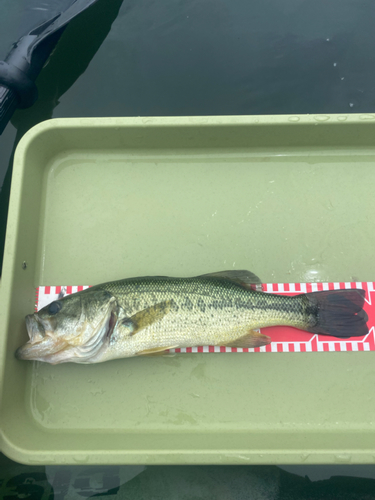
300, 289, 368, 338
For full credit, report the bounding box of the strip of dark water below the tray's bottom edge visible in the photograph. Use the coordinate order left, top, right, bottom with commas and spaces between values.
0, 455, 375, 500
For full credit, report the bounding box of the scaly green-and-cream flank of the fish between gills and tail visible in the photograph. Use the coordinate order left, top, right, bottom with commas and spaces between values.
94, 277, 306, 357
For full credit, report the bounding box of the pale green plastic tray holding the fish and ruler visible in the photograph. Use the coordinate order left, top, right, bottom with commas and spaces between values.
0, 115, 375, 464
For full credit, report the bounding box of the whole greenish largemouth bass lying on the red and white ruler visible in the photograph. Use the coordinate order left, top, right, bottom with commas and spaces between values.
15, 270, 368, 364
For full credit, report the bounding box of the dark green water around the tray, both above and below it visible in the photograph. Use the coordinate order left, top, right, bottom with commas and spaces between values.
0, 0, 375, 499
